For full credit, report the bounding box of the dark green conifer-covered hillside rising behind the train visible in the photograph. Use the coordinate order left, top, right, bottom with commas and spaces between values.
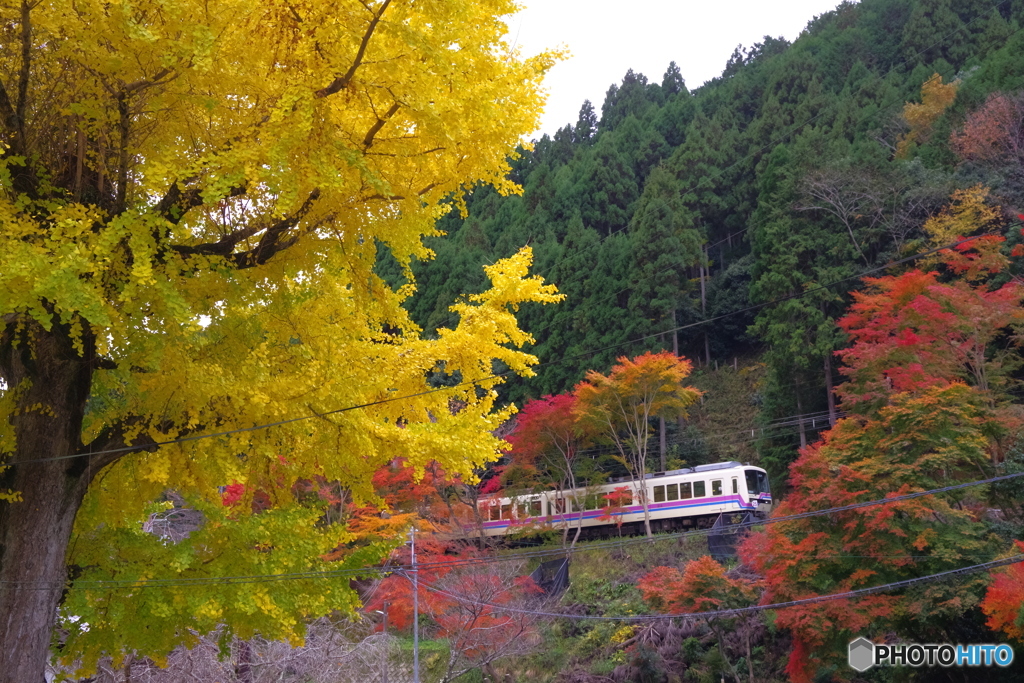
381, 0, 1024, 478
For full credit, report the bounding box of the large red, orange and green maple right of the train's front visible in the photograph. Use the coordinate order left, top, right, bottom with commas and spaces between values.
739, 233, 1024, 683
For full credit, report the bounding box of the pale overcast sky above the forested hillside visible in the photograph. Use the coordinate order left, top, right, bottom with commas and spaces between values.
509, 0, 840, 137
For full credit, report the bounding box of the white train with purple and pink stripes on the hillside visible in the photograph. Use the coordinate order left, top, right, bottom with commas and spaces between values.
478, 462, 772, 536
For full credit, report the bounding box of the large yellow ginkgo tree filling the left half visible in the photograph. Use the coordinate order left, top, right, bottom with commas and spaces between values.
0, 0, 558, 683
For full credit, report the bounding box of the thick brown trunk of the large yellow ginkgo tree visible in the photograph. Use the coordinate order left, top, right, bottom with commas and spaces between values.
0, 318, 95, 683
